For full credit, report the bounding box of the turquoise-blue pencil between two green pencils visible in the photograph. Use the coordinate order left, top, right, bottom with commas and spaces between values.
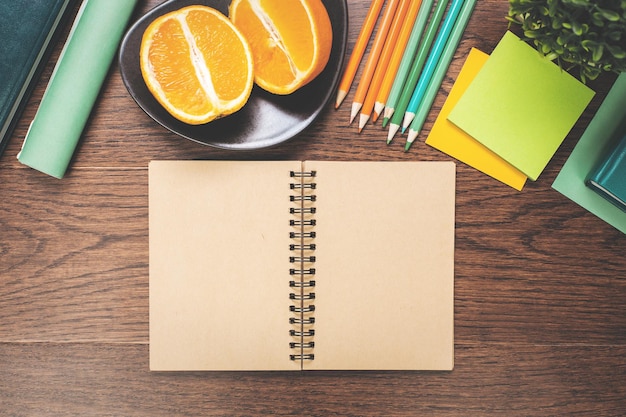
402, 0, 465, 133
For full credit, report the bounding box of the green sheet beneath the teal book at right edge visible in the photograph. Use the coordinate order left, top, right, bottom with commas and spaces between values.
552, 72, 626, 233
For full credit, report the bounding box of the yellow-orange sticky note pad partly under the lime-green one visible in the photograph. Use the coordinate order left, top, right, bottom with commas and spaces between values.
426, 48, 526, 191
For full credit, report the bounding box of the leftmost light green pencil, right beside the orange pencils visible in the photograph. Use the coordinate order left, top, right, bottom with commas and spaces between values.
383, 0, 434, 127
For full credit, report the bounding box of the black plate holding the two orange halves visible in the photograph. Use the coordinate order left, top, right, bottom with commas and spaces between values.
119, 0, 348, 150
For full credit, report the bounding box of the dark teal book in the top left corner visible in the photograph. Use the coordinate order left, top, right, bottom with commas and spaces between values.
0, 0, 74, 155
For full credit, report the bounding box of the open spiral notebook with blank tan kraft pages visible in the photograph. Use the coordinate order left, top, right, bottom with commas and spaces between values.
149, 161, 455, 371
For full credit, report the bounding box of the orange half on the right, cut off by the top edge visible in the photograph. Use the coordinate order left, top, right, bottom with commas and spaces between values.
229, 0, 333, 94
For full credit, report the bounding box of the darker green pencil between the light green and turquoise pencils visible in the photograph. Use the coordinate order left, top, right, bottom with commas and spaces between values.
383, 0, 449, 144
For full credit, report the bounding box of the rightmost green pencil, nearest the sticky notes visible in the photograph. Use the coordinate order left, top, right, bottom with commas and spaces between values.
404, 0, 476, 151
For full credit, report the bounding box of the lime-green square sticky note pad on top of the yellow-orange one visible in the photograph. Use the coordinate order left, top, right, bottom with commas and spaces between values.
448, 32, 594, 181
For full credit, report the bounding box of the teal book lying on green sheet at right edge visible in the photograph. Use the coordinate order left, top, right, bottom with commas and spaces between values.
585, 131, 626, 211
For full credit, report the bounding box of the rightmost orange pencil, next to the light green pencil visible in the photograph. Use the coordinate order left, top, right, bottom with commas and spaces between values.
372, 0, 422, 122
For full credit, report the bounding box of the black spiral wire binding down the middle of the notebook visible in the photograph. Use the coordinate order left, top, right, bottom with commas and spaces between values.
289, 171, 317, 362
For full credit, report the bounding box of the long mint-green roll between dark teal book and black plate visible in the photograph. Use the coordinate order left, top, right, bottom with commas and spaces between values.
17, 0, 137, 178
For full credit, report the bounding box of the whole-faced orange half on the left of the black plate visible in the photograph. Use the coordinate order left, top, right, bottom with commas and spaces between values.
140, 6, 254, 124
